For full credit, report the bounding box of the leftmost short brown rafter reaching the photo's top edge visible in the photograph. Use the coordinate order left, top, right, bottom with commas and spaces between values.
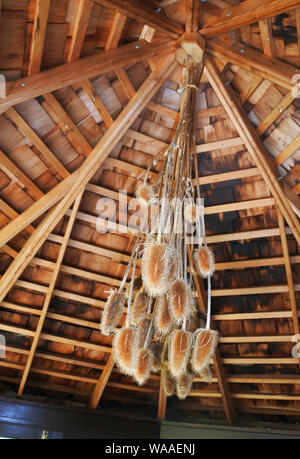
28, 0, 50, 75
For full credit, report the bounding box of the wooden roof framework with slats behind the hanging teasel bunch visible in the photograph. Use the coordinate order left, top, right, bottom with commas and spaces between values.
0, 0, 300, 430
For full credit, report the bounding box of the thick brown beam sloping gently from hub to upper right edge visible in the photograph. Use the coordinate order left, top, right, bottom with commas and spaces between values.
206, 39, 297, 90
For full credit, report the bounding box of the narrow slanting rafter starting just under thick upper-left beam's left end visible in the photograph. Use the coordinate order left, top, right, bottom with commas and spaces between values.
6, 107, 69, 178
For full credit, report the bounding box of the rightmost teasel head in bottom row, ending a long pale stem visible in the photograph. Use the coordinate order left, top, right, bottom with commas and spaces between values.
191, 328, 219, 375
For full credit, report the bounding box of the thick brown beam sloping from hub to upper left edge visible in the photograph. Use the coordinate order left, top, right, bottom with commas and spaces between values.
0, 39, 175, 114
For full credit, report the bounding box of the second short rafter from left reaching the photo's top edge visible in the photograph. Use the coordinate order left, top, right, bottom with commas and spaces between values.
67, 0, 94, 62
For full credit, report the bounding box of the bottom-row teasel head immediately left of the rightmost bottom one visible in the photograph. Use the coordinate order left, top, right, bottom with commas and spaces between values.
169, 330, 193, 378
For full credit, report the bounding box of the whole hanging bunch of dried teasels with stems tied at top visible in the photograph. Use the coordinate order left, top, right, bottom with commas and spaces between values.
100, 66, 218, 399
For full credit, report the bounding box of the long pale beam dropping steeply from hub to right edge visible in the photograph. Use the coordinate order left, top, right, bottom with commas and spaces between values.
205, 59, 300, 245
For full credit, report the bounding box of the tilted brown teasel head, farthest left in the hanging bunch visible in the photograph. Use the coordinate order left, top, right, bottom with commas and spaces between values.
100, 292, 126, 335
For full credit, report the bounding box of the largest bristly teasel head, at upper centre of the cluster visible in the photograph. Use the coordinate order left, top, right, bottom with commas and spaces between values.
142, 242, 172, 297
